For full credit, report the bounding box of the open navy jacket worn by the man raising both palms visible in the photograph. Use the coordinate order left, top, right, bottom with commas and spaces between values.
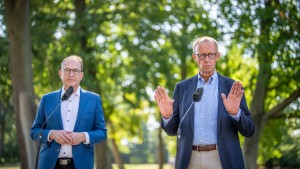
162, 74, 255, 169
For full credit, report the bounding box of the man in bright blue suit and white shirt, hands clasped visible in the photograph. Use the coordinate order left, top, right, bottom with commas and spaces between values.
30, 55, 107, 169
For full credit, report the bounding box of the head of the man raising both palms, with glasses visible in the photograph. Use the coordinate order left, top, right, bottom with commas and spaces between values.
193, 41, 220, 75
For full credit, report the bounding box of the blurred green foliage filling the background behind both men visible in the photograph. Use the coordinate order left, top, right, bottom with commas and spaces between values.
0, 0, 300, 163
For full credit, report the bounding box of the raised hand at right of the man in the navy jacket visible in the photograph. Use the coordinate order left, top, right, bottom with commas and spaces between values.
221, 81, 244, 115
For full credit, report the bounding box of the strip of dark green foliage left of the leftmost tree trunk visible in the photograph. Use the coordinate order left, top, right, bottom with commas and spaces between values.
0, 6, 19, 164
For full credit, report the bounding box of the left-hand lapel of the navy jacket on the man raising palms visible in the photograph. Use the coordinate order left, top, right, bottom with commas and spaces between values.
189, 74, 198, 133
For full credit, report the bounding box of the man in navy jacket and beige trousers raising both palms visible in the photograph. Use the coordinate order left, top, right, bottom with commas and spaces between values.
154, 37, 255, 169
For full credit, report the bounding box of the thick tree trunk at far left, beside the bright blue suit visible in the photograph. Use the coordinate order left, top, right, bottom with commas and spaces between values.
4, 0, 36, 169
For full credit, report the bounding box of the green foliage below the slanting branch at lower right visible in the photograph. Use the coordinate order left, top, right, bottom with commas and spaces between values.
258, 115, 300, 168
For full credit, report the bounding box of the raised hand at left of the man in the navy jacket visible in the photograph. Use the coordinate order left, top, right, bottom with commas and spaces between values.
154, 86, 174, 118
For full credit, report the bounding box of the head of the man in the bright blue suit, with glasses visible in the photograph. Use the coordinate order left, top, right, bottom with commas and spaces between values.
59, 58, 83, 90
